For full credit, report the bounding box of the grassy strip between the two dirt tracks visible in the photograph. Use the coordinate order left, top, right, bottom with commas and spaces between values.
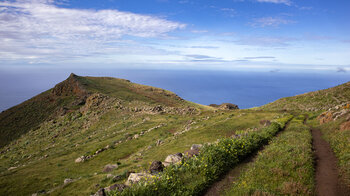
226, 117, 314, 195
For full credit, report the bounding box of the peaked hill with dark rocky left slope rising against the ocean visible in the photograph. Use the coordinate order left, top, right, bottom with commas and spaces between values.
0, 74, 201, 147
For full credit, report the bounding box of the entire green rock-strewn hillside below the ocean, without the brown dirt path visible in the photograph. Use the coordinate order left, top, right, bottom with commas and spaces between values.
0, 74, 350, 195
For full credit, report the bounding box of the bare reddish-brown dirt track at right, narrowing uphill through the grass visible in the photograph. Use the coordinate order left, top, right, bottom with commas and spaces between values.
311, 128, 350, 196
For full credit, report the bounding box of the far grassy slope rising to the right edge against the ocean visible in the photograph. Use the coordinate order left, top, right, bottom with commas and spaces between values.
260, 82, 350, 111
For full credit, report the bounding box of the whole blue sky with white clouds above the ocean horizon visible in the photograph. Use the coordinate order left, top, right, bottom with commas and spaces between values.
0, 0, 350, 72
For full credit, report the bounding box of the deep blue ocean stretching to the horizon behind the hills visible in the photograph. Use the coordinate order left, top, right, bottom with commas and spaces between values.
0, 70, 350, 111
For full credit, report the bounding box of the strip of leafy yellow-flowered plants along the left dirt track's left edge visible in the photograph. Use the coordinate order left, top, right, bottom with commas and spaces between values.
109, 115, 292, 195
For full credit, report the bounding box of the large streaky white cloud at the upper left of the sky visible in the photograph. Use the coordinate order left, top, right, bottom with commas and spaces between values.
0, 0, 186, 61
